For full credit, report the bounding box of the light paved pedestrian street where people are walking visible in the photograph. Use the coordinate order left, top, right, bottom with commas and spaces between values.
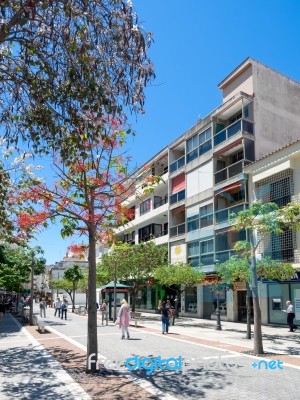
35, 309, 300, 400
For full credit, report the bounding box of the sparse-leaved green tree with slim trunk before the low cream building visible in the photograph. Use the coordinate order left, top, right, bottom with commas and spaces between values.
231, 202, 300, 354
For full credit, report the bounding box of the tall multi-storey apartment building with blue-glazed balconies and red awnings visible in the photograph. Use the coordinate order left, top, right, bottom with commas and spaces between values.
117, 58, 300, 321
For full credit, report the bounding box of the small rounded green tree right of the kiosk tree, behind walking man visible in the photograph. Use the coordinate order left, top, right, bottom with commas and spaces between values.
154, 263, 205, 325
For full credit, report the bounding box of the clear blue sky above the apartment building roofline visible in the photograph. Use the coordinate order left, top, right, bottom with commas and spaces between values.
37, 0, 300, 263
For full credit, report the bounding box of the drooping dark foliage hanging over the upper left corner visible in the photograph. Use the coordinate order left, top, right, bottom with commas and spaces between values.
0, 0, 154, 159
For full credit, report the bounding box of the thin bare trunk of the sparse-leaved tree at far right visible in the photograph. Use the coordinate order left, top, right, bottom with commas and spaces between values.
249, 231, 264, 354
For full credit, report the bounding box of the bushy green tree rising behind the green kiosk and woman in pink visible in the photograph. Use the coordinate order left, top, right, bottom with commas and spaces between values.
101, 241, 167, 311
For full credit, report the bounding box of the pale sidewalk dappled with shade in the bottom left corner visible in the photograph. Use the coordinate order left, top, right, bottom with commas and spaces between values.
0, 314, 91, 400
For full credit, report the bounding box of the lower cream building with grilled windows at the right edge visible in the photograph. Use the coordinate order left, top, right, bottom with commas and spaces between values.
245, 140, 300, 324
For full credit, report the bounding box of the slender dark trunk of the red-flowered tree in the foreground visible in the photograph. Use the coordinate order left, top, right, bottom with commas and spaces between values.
86, 227, 98, 373
